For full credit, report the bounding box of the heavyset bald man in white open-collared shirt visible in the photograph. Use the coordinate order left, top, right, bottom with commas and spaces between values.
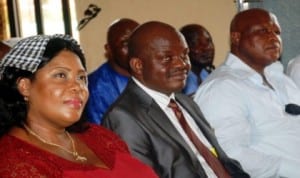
194, 8, 300, 178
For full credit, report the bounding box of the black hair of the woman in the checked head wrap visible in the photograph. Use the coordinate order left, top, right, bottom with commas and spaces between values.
0, 37, 87, 136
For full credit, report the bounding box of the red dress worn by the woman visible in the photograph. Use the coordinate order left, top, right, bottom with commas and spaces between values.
0, 125, 158, 178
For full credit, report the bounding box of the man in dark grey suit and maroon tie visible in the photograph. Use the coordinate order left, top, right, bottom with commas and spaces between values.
103, 21, 249, 178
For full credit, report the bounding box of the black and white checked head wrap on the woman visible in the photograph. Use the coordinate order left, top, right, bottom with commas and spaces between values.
0, 34, 78, 79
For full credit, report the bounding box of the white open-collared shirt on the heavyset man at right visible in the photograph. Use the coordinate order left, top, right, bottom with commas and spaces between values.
194, 54, 300, 178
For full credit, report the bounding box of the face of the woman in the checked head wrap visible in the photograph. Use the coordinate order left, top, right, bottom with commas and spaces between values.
23, 50, 89, 127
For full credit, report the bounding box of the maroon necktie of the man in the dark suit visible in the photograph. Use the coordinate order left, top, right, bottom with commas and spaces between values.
168, 99, 230, 178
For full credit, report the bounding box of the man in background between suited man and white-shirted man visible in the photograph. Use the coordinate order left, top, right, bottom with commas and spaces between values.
180, 24, 215, 96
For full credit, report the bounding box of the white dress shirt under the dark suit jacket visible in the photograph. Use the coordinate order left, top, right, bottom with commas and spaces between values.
133, 78, 217, 178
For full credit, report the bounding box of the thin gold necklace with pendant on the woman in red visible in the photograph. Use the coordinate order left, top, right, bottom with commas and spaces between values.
24, 124, 87, 162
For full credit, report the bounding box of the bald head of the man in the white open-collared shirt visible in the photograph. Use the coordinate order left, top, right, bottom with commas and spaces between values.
230, 8, 282, 73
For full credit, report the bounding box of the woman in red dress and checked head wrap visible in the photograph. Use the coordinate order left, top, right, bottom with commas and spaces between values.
0, 35, 157, 178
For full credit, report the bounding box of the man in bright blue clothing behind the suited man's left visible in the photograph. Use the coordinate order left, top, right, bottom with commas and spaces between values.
85, 18, 139, 124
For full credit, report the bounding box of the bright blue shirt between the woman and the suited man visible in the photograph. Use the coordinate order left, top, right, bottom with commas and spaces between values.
86, 62, 129, 124
